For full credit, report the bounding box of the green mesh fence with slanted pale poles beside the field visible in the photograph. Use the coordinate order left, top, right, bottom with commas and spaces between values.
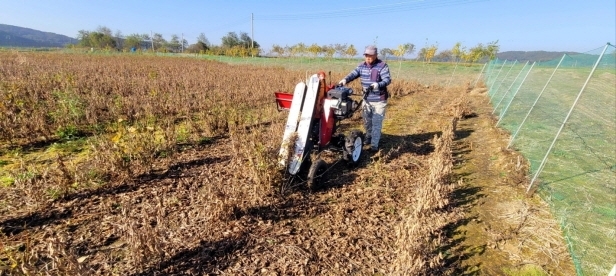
484, 44, 616, 275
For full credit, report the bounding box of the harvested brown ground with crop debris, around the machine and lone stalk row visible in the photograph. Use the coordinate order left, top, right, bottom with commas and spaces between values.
0, 81, 574, 275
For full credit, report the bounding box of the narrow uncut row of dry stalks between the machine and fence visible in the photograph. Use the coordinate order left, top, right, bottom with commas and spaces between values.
390, 119, 456, 275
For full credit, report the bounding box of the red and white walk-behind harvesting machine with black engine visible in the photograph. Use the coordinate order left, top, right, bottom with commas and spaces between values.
275, 72, 364, 189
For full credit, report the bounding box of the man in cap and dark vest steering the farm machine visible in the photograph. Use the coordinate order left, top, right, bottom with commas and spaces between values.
339, 45, 391, 152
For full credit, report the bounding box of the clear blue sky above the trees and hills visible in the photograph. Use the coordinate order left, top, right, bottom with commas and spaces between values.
0, 0, 616, 52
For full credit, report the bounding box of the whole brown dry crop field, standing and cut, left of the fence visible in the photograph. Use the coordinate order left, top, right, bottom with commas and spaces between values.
0, 52, 574, 275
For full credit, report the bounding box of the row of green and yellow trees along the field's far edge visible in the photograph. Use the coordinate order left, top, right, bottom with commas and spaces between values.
76, 27, 500, 63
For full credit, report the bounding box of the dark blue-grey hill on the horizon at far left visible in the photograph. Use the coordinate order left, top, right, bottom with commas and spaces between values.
0, 24, 78, 48
